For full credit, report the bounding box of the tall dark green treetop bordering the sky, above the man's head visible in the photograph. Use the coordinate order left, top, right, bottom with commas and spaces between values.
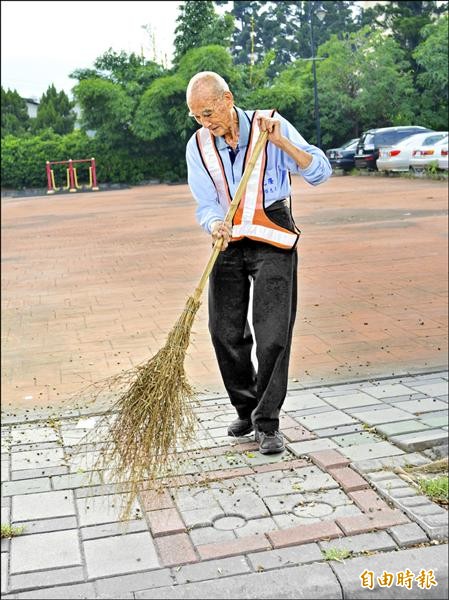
173, 0, 233, 65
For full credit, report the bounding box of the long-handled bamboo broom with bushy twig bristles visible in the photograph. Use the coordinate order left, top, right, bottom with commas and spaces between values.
77, 132, 268, 520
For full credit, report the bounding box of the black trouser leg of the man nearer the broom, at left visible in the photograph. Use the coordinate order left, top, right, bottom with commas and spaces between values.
209, 242, 257, 419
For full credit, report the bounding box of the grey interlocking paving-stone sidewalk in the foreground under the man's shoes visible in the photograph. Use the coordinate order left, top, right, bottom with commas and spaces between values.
1, 372, 448, 599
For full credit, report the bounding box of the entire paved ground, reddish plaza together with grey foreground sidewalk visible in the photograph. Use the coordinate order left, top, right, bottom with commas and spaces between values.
1, 177, 448, 600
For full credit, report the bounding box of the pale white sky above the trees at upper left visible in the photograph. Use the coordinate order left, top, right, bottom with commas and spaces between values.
1, 0, 181, 99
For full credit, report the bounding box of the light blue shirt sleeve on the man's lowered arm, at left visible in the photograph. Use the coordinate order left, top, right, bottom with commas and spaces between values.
186, 135, 225, 233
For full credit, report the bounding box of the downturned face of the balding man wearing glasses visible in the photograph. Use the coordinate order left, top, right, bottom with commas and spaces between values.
188, 87, 234, 137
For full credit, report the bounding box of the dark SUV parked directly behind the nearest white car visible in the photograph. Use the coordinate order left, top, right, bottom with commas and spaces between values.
354, 125, 431, 171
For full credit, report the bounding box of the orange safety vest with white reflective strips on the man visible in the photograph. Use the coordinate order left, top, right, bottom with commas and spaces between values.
196, 110, 299, 250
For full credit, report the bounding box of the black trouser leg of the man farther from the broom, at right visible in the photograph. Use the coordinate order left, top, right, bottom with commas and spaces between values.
248, 245, 298, 431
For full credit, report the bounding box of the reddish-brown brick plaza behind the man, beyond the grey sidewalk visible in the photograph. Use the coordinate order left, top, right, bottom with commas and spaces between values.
2, 177, 447, 406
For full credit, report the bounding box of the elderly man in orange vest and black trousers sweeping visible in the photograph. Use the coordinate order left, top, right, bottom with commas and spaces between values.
186, 71, 331, 454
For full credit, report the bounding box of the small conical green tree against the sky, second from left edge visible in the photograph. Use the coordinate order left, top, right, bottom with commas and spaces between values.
33, 84, 76, 135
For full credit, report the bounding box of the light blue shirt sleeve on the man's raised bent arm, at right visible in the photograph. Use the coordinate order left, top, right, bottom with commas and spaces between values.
274, 113, 332, 185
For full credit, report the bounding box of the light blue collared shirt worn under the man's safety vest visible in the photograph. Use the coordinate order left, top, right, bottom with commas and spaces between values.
186, 107, 332, 233
